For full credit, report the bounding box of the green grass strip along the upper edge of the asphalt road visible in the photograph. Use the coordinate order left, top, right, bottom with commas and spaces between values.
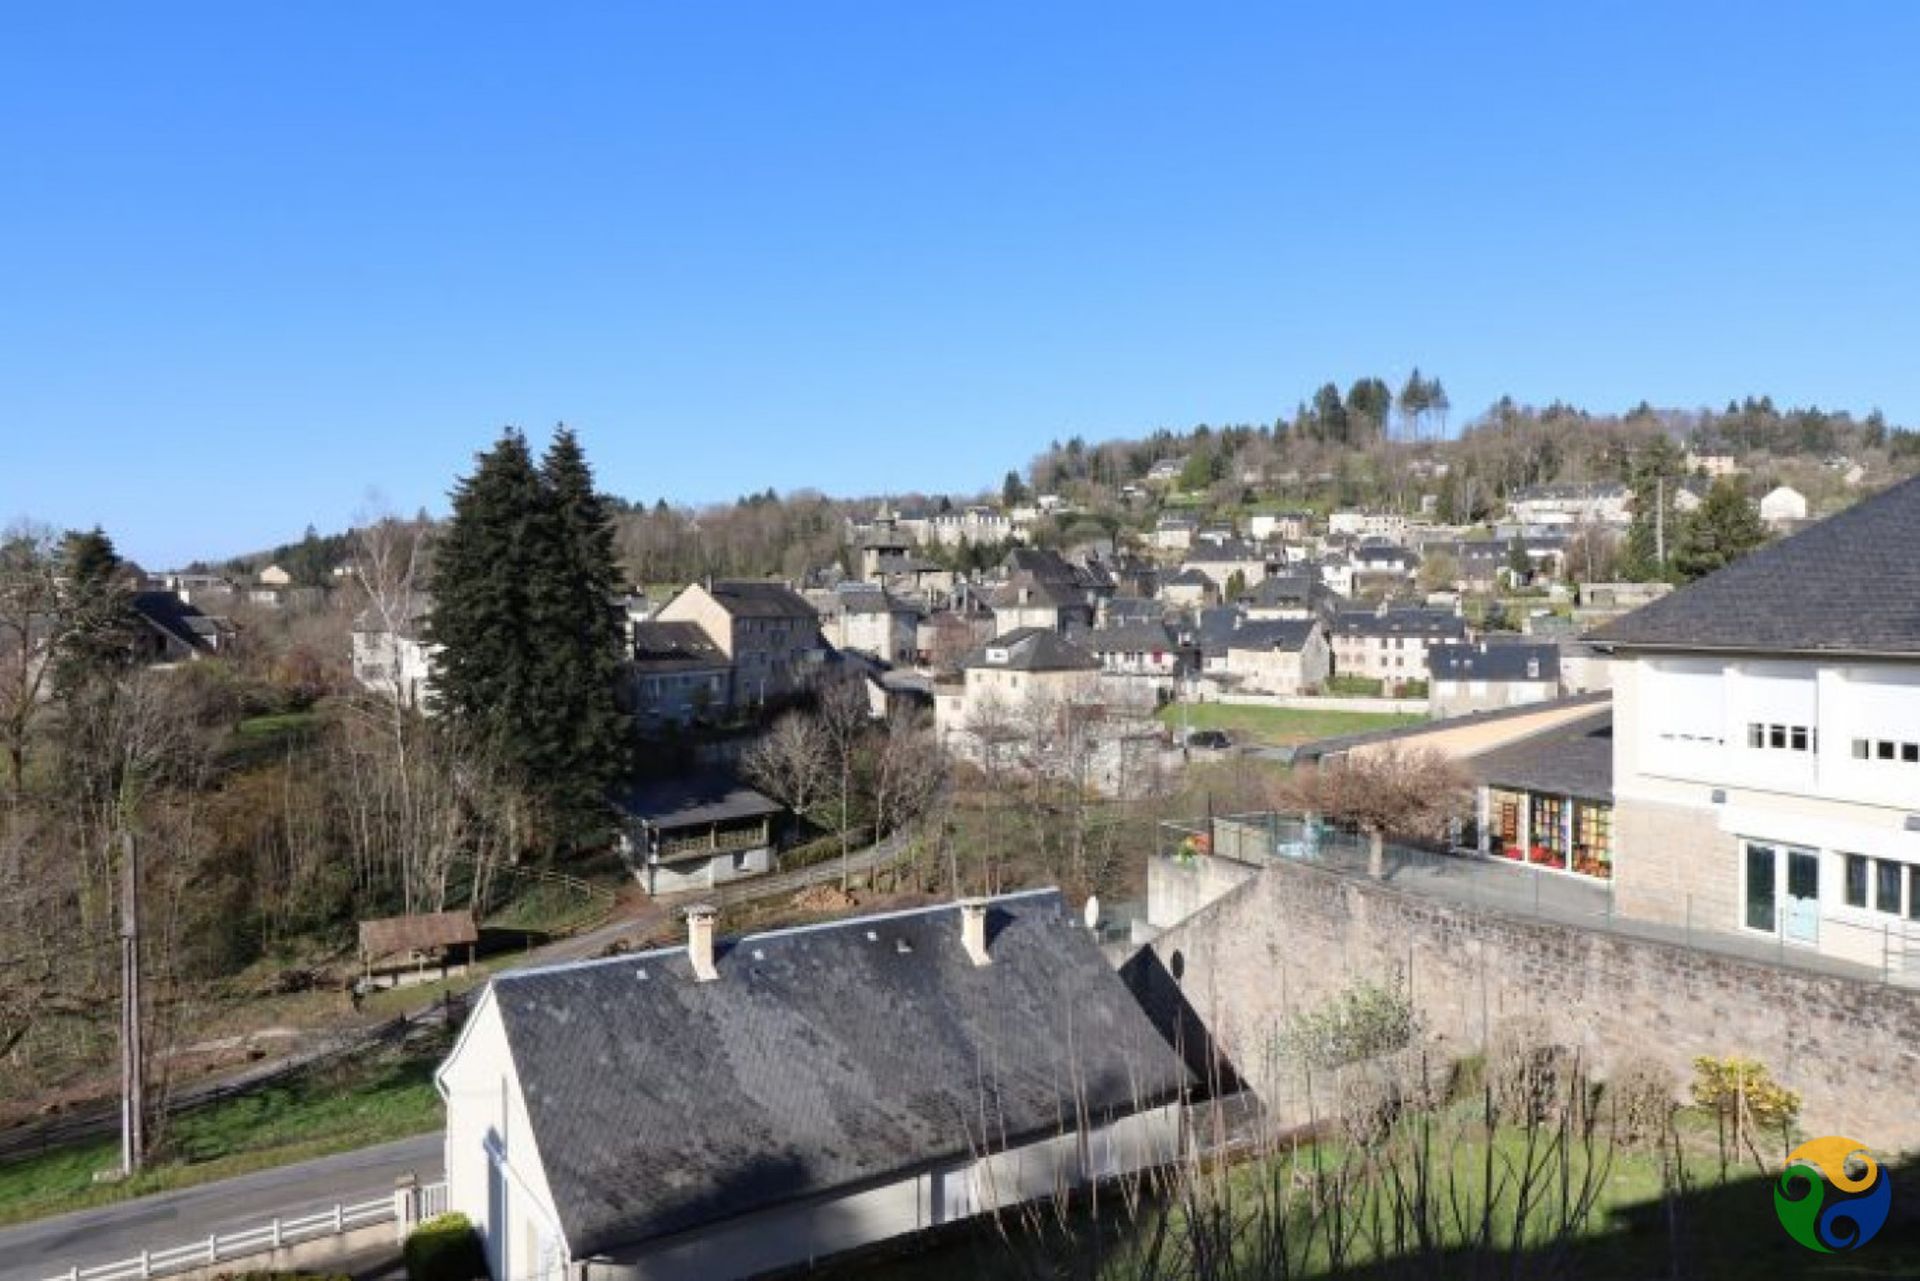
0, 1041, 445, 1223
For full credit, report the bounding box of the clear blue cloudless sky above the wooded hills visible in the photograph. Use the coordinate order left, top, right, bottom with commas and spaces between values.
0, 2, 1920, 567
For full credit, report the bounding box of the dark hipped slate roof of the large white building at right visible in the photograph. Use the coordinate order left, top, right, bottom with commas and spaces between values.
1588, 468, 1920, 655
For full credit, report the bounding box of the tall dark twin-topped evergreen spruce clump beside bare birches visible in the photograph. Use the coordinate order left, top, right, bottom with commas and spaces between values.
428, 430, 626, 851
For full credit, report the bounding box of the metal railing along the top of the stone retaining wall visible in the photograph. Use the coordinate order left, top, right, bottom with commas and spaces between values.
1158, 812, 1920, 987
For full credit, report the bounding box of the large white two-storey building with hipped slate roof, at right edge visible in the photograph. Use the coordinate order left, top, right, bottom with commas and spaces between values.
1590, 480, 1920, 978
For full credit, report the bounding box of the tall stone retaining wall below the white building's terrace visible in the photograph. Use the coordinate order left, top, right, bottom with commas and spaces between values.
1133, 862, 1920, 1150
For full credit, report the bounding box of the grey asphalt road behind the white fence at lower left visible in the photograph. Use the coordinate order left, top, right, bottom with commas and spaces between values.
0, 1133, 442, 1281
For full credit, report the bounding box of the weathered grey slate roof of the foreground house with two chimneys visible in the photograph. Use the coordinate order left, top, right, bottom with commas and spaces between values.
492, 889, 1192, 1258
